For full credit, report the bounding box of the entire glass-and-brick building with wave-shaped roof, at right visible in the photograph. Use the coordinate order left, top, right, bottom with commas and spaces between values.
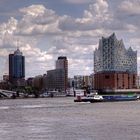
94, 33, 137, 90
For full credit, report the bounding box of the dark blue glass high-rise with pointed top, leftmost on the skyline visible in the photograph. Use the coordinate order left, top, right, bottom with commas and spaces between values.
9, 49, 25, 82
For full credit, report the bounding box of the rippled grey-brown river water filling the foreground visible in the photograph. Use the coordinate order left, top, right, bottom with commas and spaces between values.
0, 97, 140, 140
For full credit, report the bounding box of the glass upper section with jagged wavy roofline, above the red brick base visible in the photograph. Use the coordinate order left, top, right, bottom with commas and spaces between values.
94, 33, 137, 74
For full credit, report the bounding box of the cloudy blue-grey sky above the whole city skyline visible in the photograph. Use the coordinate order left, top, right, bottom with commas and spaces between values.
0, 0, 140, 78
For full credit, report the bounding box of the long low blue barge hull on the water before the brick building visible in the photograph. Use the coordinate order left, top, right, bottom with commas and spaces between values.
102, 94, 139, 101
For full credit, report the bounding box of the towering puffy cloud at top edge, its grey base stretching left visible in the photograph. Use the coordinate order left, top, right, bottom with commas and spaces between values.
59, 0, 113, 31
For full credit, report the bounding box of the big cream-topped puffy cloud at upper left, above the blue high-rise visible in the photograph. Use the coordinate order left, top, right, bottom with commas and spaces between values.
16, 5, 60, 35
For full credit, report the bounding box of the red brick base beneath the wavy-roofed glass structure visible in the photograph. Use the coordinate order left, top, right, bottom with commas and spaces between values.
94, 72, 137, 90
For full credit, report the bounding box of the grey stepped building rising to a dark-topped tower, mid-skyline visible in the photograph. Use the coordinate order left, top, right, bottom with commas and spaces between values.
45, 56, 68, 92
